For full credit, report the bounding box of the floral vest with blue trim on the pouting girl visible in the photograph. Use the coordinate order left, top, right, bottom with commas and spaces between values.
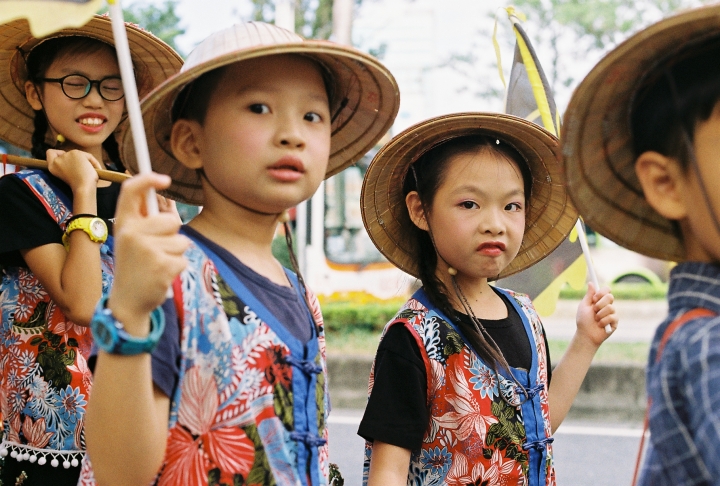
363, 289, 555, 486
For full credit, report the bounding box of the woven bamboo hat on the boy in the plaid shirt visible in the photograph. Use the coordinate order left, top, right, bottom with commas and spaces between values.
560, 5, 720, 261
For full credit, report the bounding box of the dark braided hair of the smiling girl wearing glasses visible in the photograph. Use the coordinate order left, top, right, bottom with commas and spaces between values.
25, 36, 125, 172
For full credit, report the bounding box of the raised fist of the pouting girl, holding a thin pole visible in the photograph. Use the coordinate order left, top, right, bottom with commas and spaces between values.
576, 283, 618, 346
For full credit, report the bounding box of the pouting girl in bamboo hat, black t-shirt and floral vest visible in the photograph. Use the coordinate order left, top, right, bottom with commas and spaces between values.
358, 113, 617, 485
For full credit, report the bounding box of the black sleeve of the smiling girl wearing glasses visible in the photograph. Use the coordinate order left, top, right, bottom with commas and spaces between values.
0, 174, 63, 266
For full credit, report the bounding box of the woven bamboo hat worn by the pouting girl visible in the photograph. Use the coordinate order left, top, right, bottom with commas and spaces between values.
360, 113, 577, 278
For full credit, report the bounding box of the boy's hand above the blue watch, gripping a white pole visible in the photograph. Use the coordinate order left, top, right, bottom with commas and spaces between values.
108, 173, 190, 335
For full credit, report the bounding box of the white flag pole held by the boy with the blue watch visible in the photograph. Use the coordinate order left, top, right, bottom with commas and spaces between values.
107, 0, 158, 215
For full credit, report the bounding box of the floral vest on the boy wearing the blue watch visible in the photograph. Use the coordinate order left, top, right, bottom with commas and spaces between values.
146, 242, 329, 486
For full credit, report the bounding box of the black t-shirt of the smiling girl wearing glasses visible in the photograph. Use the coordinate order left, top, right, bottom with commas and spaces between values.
0, 173, 120, 266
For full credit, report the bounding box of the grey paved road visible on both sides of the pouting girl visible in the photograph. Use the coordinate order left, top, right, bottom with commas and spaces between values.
330, 409, 642, 486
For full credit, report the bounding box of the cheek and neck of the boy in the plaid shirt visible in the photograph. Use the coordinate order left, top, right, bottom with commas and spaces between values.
681, 108, 720, 262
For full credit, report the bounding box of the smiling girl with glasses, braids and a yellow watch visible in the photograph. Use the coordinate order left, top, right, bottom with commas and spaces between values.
0, 17, 182, 486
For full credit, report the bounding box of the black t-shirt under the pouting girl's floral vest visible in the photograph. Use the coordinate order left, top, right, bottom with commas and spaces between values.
358, 291, 551, 450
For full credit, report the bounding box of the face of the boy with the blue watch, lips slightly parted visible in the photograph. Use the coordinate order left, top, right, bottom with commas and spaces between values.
191, 55, 330, 213
